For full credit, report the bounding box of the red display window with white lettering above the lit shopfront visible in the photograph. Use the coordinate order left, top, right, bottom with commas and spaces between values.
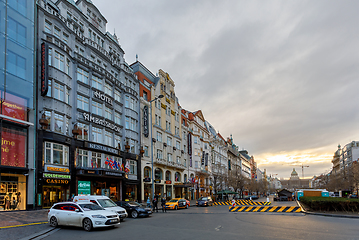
1, 123, 27, 167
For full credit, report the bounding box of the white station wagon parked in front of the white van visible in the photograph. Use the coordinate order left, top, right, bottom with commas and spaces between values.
47, 202, 120, 231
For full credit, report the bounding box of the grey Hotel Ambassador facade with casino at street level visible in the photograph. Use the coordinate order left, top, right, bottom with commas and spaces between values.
37, 0, 141, 208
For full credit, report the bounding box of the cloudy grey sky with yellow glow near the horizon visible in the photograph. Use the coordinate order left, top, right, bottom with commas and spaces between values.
92, 0, 359, 178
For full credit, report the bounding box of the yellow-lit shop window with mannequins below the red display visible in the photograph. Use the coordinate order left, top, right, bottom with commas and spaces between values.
0, 173, 26, 211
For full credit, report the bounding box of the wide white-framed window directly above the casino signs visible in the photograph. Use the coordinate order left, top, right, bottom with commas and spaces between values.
45, 142, 69, 166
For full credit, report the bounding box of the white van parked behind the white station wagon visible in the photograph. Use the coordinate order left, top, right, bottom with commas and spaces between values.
74, 195, 128, 222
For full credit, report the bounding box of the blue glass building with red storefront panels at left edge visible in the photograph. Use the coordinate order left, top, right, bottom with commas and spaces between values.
0, 0, 36, 211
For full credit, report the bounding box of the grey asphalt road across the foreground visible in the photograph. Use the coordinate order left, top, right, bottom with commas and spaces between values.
37, 206, 359, 240
